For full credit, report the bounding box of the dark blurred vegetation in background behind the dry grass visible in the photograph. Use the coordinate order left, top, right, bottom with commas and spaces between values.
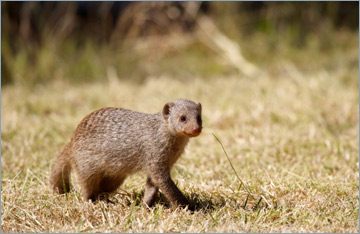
1, 2, 359, 85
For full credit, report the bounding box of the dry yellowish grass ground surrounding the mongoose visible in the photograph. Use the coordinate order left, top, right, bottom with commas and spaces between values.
1, 63, 359, 232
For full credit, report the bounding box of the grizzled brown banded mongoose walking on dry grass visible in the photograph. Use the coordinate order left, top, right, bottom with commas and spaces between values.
50, 99, 202, 207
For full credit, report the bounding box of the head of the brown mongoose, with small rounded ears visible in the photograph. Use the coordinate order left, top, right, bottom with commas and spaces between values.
162, 99, 202, 137
